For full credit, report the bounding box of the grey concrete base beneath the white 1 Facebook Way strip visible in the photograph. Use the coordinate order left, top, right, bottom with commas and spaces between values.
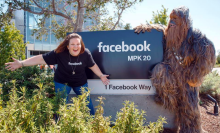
69, 94, 175, 129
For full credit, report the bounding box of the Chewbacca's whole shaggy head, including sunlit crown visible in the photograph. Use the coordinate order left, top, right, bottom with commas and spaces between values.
165, 7, 191, 50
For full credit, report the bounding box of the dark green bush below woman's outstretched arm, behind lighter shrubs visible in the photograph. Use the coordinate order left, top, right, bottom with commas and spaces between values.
0, 66, 54, 101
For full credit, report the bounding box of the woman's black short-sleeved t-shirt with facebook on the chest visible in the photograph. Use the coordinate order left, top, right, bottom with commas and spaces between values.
43, 49, 95, 87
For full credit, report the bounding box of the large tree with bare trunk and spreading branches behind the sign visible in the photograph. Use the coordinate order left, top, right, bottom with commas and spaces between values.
6, 0, 143, 39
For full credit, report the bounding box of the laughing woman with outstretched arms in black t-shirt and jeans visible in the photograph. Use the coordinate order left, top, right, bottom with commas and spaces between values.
5, 33, 109, 115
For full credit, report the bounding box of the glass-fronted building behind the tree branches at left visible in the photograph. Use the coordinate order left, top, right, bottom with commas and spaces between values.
12, 3, 95, 58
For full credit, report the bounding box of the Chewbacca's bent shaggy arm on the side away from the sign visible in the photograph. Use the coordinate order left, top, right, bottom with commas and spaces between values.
187, 30, 216, 87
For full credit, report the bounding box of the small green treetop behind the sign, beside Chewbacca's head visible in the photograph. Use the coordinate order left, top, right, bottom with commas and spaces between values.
147, 5, 169, 25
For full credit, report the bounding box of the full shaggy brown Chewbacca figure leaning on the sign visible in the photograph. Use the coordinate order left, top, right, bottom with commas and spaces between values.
135, 7, 216, 133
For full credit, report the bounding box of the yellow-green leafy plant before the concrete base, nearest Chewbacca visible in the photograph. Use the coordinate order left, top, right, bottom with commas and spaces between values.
114, 101, 166, 133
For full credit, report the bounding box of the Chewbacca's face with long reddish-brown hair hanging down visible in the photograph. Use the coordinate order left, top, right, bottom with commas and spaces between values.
165, 10, 187, 50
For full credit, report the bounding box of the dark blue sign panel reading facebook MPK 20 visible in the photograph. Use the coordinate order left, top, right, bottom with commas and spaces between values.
69, 30, 163, 79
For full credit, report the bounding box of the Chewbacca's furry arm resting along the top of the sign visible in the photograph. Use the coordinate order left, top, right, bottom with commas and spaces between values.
134, 24, 166, 33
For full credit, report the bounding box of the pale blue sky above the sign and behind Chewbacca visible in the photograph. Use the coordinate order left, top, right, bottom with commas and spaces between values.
118, 0, 220, 52
